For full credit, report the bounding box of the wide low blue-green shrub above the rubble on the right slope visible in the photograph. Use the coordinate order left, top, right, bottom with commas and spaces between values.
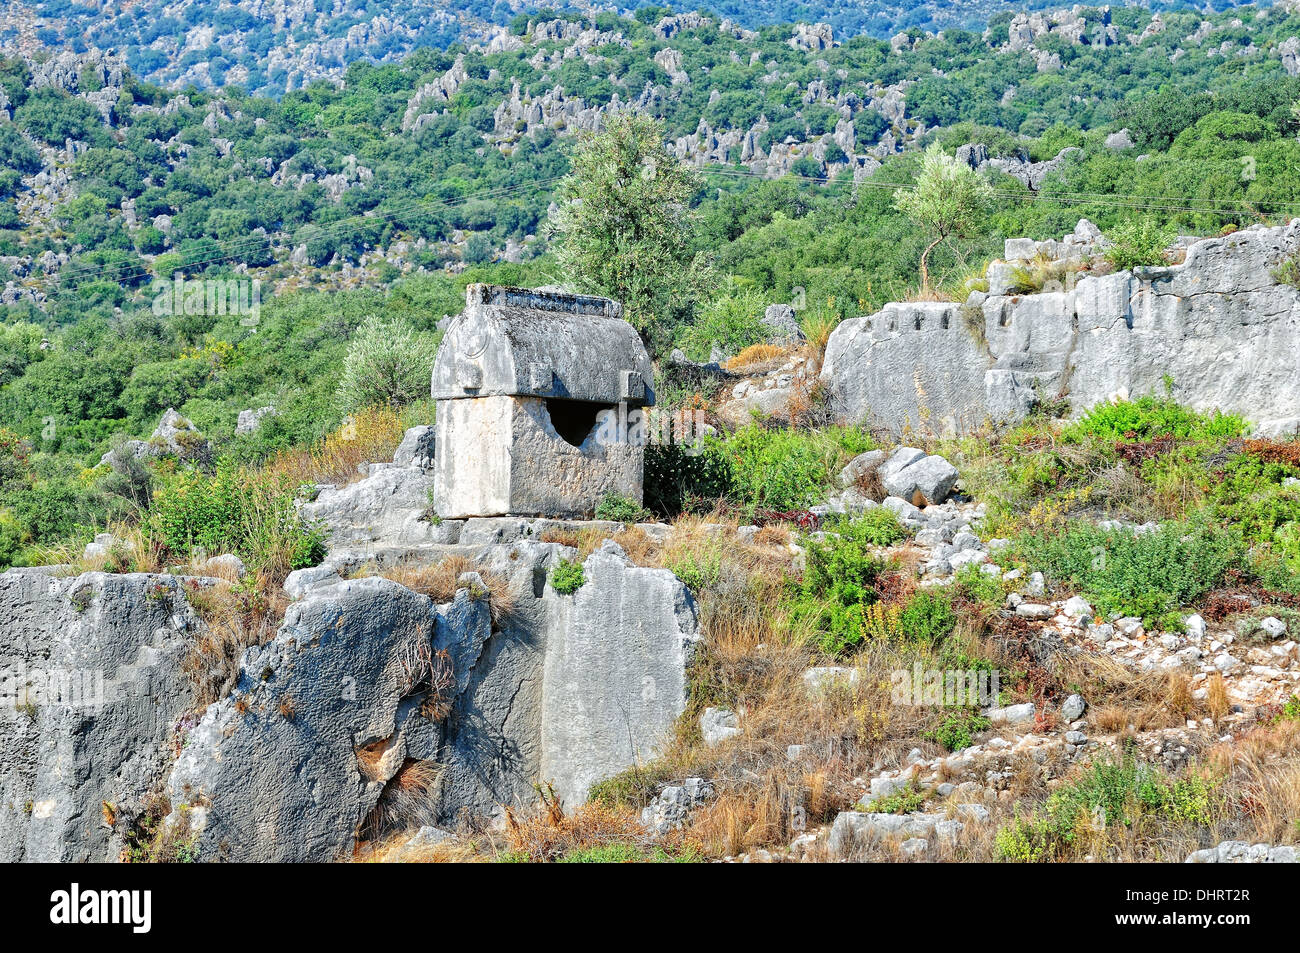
1017, 521, 1245, 628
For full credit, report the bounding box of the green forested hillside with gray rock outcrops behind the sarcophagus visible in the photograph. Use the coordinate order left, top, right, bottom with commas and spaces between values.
0, 5, 1300, 560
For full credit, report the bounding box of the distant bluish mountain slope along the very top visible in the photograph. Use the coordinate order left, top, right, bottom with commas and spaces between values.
0, 0, 1279, 95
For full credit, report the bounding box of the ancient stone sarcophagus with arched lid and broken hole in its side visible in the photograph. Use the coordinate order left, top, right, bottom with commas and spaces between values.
432, 285, 654, 519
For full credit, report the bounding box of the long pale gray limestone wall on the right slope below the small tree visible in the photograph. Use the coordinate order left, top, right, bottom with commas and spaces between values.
820, 222, 1300, 433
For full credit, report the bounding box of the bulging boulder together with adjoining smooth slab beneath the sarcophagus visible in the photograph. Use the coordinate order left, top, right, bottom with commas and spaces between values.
169, 521, 697, 859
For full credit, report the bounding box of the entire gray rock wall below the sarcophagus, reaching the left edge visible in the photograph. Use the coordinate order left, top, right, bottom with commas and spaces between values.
0, 504, 697, 861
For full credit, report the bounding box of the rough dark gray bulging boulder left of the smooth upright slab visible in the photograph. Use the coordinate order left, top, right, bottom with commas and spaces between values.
168, 577, 506, 861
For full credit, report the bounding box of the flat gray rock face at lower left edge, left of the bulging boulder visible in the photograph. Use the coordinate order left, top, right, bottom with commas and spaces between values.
0, 569, 202, 862
